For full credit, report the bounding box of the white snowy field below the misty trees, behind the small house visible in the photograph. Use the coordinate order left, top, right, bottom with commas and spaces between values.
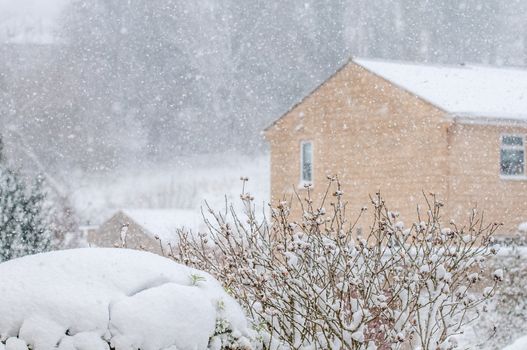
71, 154, 270, 224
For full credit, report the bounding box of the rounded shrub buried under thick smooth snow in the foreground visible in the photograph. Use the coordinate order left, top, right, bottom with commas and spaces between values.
0, 248, 256, 350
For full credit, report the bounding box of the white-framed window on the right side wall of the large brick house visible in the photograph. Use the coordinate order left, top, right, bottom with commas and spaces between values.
500, 135, 525, 176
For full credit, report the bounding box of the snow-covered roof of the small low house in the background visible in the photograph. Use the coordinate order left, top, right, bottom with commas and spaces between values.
121, 209, 203, 242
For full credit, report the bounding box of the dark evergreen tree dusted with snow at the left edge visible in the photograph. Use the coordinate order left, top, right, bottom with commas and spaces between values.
0, 143, 53, 261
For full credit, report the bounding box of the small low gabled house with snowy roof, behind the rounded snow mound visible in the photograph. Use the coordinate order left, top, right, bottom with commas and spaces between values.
88, 209, 203, 254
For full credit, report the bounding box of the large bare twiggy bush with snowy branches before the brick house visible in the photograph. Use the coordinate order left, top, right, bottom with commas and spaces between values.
169, 178, 503, 350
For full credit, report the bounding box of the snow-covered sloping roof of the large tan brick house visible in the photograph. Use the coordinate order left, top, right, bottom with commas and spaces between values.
353, 58, 527, 120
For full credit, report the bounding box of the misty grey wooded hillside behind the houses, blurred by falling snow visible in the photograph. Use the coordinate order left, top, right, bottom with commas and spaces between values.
0, 0, 527, 221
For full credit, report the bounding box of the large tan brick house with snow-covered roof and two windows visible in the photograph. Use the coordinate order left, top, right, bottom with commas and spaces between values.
265, 59, 527, 233
